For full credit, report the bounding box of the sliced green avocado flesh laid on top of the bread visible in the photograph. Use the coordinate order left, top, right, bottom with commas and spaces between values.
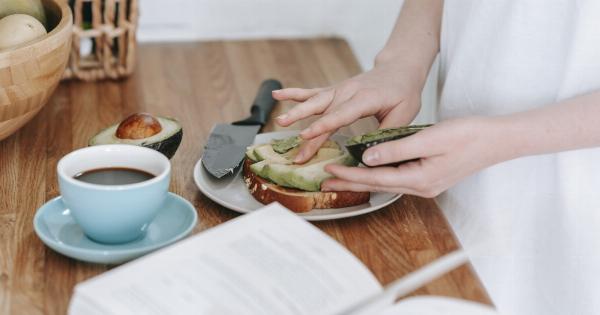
246, 137, 358, 191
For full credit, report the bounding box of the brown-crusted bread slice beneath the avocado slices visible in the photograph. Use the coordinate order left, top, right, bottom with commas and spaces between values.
242, 159, 370, 212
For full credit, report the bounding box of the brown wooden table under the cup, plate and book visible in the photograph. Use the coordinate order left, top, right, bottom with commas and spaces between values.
0, 39, 490, 315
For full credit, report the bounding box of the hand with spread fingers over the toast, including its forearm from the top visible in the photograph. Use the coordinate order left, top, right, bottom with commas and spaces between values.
273, 0, 443, 163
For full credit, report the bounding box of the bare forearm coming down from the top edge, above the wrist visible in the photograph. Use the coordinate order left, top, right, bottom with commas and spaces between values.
375, 0, 443, 84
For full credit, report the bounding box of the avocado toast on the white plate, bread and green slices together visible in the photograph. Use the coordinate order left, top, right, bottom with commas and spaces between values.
242, 136, 370, 212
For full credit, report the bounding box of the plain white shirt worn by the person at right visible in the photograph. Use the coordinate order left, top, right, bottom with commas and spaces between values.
438, 0, 600, 315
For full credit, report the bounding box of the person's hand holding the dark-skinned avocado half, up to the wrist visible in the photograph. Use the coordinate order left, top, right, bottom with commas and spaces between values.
322, 117, 511, 198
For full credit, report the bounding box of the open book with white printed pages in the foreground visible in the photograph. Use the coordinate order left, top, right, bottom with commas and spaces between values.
69, 204, 493, 315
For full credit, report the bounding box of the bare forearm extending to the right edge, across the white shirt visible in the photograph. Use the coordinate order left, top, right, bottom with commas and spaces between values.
491, 91, 600, 160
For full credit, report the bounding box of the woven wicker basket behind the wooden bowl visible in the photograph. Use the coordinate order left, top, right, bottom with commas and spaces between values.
63, 0, 139, 81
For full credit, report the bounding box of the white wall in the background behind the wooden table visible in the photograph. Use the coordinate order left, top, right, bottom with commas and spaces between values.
138, 0, 435, 121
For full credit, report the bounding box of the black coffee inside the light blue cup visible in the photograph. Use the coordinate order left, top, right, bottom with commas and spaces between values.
73, 167, 155, 185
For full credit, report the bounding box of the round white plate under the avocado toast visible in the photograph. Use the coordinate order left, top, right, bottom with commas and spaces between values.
194, 130, 400, 221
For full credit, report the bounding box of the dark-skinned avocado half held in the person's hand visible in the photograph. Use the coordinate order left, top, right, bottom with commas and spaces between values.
346, 124, 432, 166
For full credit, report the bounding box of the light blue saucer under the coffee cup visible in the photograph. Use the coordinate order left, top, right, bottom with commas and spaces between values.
33, 193, 198, 264
